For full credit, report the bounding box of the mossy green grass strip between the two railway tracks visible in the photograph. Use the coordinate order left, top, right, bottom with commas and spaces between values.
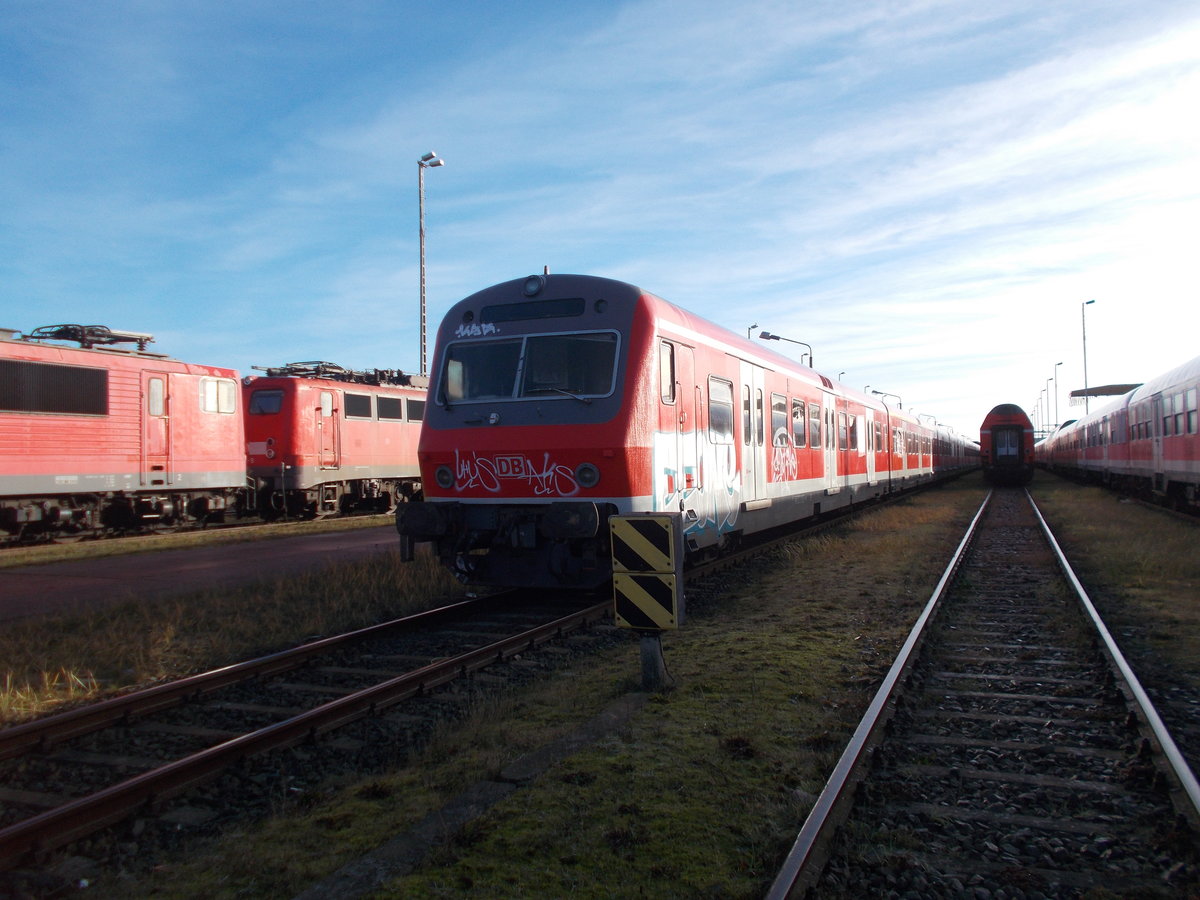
96, 476, 984, 898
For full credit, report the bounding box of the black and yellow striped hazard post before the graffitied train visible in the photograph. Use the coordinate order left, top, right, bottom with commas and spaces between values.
608, 512, 684, 691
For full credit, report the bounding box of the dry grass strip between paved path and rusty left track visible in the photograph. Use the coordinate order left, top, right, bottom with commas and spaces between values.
0, 553, 461, 724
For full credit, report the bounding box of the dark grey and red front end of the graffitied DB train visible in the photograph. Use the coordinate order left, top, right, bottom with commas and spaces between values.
396, 275, 650, 589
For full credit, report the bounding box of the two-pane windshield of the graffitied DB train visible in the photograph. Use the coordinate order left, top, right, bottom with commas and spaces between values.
440, 331, 617, 403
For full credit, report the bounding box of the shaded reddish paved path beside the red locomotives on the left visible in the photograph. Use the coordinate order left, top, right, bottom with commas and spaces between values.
0, 526, 398, 622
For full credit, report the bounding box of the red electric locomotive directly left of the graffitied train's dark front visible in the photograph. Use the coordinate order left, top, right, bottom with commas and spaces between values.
242, 362, 428, 516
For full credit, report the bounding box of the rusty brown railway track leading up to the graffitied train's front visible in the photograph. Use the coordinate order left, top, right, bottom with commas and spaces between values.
0, 596, 611, 871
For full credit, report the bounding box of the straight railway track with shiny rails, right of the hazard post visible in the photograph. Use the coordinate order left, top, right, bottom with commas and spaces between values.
768, 490, 1200, 898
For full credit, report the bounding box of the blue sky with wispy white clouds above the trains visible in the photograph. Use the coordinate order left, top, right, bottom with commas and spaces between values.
0, 0, 1200, 434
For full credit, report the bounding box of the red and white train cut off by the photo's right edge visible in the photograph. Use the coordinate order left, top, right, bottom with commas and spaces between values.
1037, 358, 1200, 512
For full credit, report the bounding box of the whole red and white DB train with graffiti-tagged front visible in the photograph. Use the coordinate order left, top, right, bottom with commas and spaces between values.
396, 275, 978, 588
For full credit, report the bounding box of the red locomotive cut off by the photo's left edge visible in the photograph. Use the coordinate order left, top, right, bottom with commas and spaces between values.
0, 325, 247, 540
